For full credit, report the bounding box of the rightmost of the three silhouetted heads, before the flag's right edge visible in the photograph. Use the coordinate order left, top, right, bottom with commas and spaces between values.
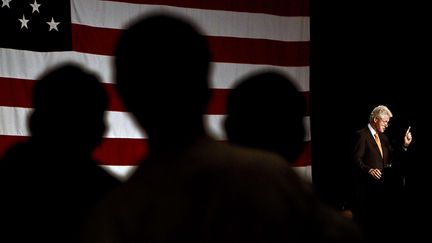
225, 71, 306, 162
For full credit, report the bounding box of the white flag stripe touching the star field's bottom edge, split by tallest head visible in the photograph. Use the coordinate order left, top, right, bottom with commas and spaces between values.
0, 48, 309, 91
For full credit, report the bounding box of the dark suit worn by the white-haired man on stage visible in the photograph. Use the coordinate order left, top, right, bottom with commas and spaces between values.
350, 127, 403, 239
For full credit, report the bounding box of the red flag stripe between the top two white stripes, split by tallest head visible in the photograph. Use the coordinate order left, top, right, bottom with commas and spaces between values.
72, 24, 309, 67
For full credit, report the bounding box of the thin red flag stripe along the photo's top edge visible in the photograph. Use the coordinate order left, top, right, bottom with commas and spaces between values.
103, 0, 309, 16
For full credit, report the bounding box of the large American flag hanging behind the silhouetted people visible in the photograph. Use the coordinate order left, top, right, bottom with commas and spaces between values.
0, 0, 311, 178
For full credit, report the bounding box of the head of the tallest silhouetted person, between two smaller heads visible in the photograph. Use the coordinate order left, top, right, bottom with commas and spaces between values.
115, 14, 210, 139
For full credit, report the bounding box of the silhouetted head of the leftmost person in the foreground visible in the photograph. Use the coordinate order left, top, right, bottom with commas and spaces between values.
30, 64, 108, 153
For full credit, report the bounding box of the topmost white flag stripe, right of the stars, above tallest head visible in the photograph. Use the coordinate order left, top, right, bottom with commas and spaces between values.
71, 0, 310, 41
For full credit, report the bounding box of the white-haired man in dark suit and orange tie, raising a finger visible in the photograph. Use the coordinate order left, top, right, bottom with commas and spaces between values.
353, 105, 412, 240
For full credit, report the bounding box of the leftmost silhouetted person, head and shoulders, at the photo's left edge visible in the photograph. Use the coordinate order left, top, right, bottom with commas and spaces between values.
0, 64, 120, 242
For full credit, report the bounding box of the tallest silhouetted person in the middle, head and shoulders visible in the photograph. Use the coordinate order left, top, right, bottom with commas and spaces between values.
84, 14, 364, 243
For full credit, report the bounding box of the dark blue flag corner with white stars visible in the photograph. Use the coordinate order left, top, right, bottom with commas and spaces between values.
0, 0, 72, 51
